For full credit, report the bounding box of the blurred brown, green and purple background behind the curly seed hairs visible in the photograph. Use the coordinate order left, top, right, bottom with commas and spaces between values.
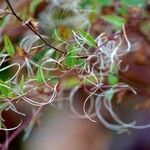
0, 0, 150, 150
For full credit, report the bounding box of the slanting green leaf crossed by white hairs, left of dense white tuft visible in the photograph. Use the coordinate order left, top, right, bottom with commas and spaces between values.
79, 29, 96, 46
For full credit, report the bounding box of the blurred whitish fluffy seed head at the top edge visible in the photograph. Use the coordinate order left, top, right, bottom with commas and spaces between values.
39, 0, 91, 29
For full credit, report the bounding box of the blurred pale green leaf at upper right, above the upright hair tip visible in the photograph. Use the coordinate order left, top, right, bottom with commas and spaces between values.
101, 15, 126, 28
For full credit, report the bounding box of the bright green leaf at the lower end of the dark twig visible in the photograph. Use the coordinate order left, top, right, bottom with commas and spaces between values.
64, 45, 77, 68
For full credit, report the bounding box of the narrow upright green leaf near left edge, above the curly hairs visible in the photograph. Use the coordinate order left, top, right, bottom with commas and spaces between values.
4, 34, 15, 56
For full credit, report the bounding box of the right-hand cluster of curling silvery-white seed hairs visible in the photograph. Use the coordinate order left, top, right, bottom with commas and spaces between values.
70, 25, 150, 133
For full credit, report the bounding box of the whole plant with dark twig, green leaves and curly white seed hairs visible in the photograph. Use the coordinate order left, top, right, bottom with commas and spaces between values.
0, 0, 150, 148
